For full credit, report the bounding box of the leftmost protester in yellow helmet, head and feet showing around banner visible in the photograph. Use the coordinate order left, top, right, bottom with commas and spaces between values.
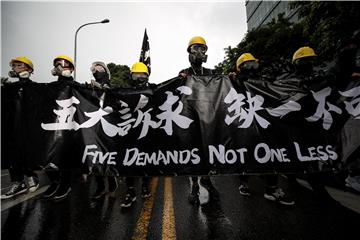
1, 57, 39, 199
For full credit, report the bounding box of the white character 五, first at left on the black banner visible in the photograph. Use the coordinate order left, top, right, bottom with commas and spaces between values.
41, 96, 80, 131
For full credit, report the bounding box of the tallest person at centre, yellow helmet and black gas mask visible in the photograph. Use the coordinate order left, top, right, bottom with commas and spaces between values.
179, 36, 213, 204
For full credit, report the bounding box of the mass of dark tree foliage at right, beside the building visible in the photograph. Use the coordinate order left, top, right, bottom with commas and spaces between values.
215, 1, 360, 74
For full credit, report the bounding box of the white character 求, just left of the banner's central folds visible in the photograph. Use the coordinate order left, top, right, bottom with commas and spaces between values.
157, 86, 193, 135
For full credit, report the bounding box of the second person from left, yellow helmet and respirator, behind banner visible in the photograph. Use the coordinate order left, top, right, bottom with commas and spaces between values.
43, 55, 75, 200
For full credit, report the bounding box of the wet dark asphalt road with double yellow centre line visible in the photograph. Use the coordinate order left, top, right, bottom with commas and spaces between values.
1, 172, 360, 240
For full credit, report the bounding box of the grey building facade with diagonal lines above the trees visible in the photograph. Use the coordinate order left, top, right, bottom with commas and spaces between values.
245, 0, 299, 30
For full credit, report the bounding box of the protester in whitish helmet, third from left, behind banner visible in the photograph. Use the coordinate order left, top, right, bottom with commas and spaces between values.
88, 62, 118, 199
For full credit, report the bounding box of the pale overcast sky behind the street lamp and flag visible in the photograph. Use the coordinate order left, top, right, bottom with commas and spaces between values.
1, 1, 247, 83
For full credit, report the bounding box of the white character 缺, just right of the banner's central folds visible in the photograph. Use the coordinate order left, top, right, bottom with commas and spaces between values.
224, 88, 270, 128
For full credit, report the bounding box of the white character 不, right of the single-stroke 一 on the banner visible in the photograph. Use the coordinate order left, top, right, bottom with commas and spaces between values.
305, 87, 342, 130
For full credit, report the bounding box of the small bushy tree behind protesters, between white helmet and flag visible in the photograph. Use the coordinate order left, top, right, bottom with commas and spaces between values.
107, 63, 130, 87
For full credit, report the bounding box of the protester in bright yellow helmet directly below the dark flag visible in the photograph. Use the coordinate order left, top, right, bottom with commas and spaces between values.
121, 62, 154, 208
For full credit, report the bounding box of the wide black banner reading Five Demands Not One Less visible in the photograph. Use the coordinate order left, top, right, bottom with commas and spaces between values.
1, 75, 360, 176
